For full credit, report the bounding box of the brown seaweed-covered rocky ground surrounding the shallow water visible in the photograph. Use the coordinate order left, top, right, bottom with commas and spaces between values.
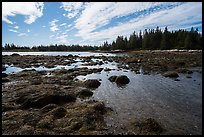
2, 51, 202, 135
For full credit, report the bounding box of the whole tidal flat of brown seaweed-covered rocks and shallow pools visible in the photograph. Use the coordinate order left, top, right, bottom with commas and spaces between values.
2, 51, 202, 135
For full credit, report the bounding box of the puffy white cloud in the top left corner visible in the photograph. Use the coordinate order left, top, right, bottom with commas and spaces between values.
2, 2, 44, 24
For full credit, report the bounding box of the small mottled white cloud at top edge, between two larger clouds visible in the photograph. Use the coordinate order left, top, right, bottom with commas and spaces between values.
60, 2, 83, 18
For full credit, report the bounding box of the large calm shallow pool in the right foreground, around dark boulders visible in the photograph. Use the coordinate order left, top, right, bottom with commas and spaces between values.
77, 70, 202, 135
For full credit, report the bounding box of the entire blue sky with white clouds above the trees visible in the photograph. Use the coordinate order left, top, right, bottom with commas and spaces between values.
2, 2, 202, 47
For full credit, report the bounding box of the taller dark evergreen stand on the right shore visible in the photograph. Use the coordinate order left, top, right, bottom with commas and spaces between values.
100, 27, 202, 50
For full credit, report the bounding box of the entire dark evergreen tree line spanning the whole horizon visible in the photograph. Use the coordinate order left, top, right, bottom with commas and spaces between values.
2, 27, 202, 51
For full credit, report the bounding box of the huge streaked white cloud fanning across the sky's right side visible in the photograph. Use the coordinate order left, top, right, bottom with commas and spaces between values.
75, 2, 202, 42
